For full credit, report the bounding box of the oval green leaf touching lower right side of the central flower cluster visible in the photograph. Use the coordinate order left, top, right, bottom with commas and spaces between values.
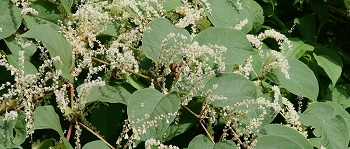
204, 73, 257, 107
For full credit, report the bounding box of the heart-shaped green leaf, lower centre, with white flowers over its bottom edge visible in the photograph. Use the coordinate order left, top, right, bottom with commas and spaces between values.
127, 88, 180, 140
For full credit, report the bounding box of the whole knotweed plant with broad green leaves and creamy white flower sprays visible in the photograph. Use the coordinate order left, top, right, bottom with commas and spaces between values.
0, 0, 350, 149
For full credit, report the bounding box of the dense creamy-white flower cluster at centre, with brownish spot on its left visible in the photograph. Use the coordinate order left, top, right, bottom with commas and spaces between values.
154, 33, 226, 105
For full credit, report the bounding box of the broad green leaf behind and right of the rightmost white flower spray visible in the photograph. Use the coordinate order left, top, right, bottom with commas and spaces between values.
268, 59, 319, 101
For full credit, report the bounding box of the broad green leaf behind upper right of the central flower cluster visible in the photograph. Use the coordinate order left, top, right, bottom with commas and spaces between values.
194, 27, 253, 72
